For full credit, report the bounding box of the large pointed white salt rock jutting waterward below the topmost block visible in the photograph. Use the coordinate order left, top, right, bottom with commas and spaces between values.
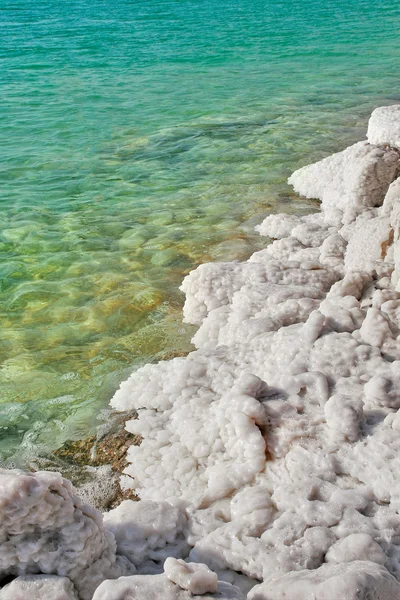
289, 142, 400, 225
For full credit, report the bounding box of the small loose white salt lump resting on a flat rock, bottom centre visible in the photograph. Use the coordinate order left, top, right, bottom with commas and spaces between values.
164, 557, 218, 596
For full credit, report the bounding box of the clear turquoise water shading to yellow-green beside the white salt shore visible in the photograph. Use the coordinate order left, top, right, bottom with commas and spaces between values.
0, 0, 400, 463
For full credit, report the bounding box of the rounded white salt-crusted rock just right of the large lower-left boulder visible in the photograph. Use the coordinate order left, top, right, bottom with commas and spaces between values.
104, 500, 189, 572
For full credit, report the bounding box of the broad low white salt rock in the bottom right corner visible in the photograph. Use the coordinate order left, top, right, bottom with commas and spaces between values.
247, 561, 400, 600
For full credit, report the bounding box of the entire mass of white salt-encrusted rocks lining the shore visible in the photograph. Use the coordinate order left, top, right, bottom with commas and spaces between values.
0, 106, 400, 600
